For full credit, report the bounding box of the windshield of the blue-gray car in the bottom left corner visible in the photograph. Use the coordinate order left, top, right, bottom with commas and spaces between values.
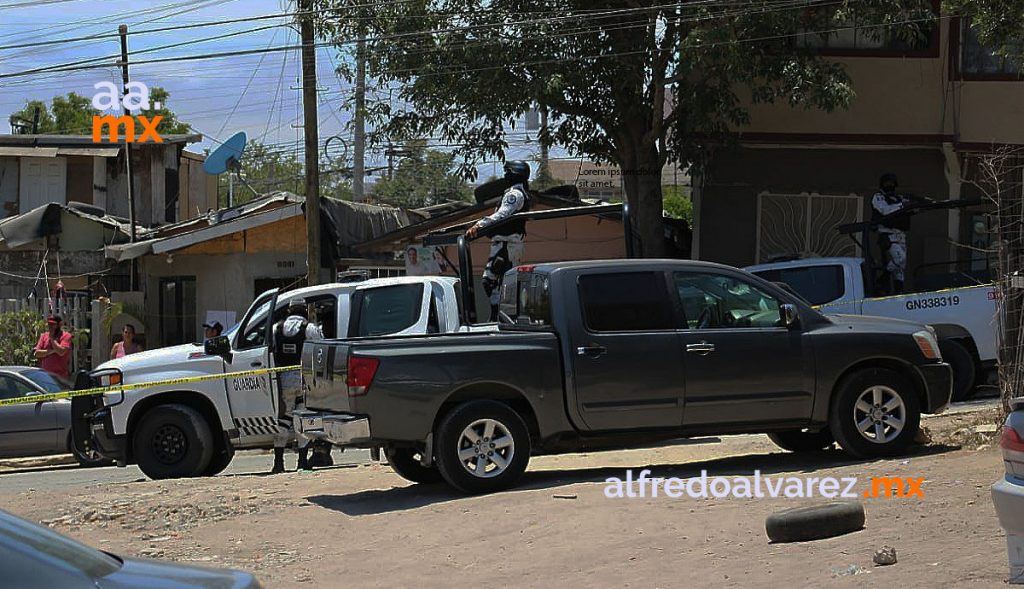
0, 510, 121, 579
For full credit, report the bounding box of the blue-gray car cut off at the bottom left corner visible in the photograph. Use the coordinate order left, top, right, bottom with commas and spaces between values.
0, 510, 261, 589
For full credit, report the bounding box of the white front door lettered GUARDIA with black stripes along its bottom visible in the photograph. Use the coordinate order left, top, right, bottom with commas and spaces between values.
224, 289, 278, 446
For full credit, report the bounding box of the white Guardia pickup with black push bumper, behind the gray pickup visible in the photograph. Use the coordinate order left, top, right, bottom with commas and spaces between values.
72, 277, 487, 478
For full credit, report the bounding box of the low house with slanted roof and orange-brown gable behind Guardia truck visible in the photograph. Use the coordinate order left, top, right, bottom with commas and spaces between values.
105, 193, 425, 347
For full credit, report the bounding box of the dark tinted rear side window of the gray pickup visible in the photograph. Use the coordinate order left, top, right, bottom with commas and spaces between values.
580, 272, 675, 332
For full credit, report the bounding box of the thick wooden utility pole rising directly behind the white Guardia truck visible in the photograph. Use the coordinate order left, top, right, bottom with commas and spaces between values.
299, 0, 321, 286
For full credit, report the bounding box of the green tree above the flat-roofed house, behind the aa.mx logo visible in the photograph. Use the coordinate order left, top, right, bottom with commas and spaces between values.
10, 86, 191, 135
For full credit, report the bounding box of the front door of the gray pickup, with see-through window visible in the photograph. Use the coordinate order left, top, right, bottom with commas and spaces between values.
673, 270, 814, 426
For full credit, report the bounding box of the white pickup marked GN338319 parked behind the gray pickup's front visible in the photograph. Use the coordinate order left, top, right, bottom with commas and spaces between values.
743, 258, 998, 401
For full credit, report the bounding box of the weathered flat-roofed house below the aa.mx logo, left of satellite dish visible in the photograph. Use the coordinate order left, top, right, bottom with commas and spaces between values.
0, 134, 217, 226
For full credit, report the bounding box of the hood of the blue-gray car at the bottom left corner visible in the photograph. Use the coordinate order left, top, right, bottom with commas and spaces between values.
96, 558, 260, 589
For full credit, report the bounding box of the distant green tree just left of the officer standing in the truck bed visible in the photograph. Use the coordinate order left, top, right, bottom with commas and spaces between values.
370, 139, 473, 208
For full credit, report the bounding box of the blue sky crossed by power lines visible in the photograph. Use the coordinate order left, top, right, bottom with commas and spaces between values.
0, 0, 544, 182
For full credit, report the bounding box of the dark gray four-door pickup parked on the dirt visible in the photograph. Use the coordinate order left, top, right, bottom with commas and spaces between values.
295, 260, 951, 493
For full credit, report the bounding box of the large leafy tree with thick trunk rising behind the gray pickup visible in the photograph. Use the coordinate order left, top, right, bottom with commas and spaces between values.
319, 0, 935, 256
